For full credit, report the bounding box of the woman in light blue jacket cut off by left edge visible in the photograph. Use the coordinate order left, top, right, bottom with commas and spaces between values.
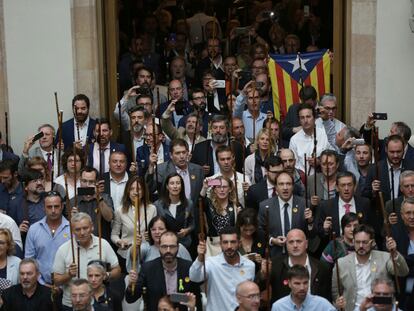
0, 228, 20, 291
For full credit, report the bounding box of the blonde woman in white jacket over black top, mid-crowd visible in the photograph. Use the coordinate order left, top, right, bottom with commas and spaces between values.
244, 129, 275, 184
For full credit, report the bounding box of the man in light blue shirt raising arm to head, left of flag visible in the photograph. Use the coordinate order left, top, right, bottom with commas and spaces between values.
233, 81, 266, 142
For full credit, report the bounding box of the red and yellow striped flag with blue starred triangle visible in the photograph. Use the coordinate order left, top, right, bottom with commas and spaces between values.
268, 49, 331, 120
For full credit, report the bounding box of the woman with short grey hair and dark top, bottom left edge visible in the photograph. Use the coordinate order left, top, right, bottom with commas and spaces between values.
87, 260, 123, 311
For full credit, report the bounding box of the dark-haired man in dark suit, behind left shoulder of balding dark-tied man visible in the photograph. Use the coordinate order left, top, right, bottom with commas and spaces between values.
246, 156, 283, 211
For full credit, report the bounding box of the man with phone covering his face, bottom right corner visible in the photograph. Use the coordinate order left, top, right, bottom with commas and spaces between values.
360, 278, 402, 311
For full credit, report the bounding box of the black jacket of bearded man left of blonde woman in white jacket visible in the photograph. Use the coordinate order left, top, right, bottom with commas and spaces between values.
191, 139, 244, 176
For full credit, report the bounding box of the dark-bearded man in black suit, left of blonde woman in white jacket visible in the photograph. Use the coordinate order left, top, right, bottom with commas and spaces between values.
191, 115, 244, 176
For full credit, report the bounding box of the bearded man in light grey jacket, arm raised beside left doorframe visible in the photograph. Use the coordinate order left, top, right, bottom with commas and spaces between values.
114, 67, 167, 131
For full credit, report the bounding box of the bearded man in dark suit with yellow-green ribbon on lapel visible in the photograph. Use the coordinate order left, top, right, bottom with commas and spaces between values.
125, 231, 202, 311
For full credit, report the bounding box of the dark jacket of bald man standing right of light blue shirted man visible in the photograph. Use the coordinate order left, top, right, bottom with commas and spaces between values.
264, 256, 331, 303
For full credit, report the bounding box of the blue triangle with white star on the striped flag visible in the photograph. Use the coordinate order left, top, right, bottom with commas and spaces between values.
270, 49, 327, 83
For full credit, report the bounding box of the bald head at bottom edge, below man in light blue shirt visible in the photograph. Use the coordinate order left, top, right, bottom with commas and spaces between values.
236, 281, 260, 311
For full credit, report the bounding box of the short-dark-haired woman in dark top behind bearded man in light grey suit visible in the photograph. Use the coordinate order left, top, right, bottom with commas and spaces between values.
321, 212, 359, 268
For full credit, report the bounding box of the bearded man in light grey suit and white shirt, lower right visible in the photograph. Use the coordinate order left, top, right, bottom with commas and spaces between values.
332, 225, 409, 311
